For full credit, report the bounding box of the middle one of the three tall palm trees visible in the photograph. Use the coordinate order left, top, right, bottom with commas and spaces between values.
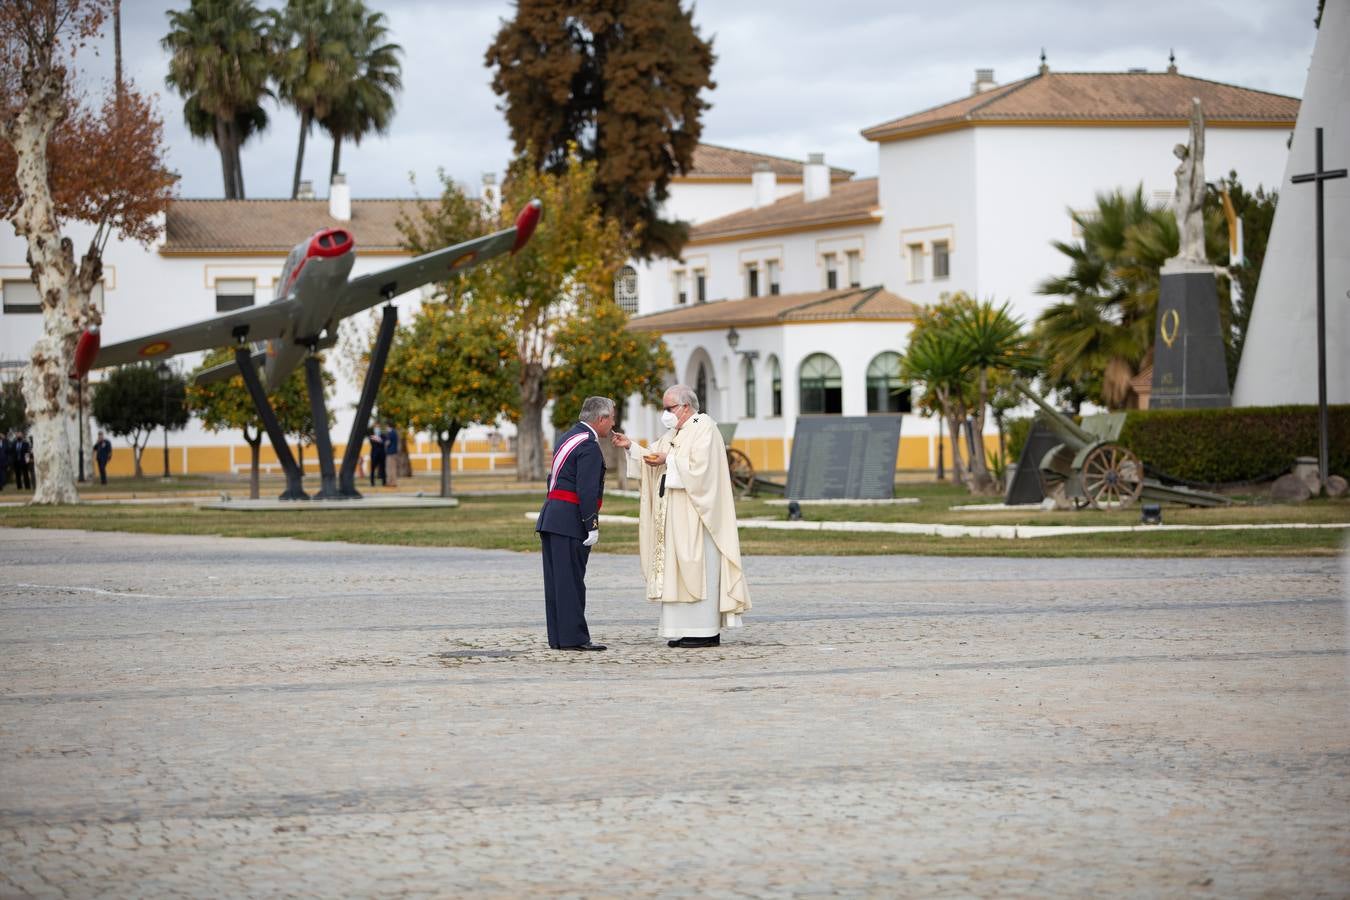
273, 0, 356, 198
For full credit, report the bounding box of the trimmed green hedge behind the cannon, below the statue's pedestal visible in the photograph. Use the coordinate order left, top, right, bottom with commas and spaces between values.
1117, 406, 1350, 484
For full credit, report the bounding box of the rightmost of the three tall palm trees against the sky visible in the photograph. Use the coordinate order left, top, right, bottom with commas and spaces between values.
319, 0, 404, 182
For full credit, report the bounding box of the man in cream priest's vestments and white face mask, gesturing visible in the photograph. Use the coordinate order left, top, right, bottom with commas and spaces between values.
613, 385, 751, 648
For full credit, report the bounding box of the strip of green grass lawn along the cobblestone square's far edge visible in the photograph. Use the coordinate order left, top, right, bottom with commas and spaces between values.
0, 476, 1350, 557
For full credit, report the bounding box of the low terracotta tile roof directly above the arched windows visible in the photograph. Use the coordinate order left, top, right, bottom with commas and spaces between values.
628, 287, 918, 332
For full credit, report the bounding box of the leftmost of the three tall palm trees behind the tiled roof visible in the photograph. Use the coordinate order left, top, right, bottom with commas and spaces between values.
161, 0, 273, 200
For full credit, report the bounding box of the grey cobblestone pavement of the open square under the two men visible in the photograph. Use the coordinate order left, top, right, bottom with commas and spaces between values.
0, 530, 1350, 897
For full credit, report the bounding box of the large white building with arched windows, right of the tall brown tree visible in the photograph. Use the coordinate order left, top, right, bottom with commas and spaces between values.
629, 65, 1299, 468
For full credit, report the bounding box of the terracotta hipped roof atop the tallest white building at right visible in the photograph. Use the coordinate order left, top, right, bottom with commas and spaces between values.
863, 72, 1299, 140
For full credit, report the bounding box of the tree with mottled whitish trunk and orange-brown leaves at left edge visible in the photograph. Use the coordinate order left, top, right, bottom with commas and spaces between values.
0, 0, 178, 503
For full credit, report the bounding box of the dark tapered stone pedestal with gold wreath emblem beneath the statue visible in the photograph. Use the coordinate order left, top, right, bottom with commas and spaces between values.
1149, 260, 1231, 409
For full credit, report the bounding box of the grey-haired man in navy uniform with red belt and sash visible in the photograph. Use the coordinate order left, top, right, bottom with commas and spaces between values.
535, 397, 614, 650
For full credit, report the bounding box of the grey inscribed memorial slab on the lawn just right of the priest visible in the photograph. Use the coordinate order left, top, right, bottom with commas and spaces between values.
787, 416, 900, 501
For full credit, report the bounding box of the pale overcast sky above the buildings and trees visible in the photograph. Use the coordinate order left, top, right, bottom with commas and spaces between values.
99, 0, 1316, 197
